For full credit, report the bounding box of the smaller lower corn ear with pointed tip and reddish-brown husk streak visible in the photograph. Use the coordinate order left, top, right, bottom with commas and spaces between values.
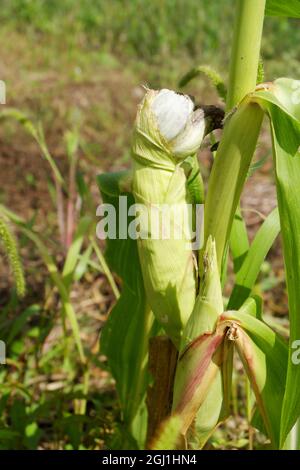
173, 237, 225, 448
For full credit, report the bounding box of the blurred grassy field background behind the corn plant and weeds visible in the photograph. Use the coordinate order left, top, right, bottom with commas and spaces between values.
0, 0, 300, 449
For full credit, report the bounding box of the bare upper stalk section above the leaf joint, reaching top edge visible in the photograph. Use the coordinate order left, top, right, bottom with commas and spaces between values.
226, 0, 266, 110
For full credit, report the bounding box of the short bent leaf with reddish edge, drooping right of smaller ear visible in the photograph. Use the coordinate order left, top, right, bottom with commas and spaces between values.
223, 306, 288, 448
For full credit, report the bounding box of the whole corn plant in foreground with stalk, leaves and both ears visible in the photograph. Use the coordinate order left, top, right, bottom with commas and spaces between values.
98, 0, 300, 449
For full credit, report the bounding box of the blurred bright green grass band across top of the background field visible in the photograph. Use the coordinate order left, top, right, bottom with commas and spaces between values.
0, 0, 300, 75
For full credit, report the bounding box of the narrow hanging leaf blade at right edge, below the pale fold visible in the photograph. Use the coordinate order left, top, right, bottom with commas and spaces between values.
272, 121, 300, 444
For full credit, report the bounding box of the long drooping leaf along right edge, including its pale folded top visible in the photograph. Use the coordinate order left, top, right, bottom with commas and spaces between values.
254, 79, 300, 446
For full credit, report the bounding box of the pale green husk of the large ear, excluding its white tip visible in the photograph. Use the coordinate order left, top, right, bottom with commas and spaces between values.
132, 90, 199, 348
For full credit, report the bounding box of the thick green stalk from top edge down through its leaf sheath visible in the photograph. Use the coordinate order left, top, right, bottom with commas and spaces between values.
205, 0, 265, 271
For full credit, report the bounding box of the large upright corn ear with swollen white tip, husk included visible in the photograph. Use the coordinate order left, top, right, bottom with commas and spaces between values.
132, 90, 205, 347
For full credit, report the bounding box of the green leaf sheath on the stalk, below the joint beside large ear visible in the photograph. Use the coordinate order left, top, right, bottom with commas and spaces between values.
204, 103, 263, 272
